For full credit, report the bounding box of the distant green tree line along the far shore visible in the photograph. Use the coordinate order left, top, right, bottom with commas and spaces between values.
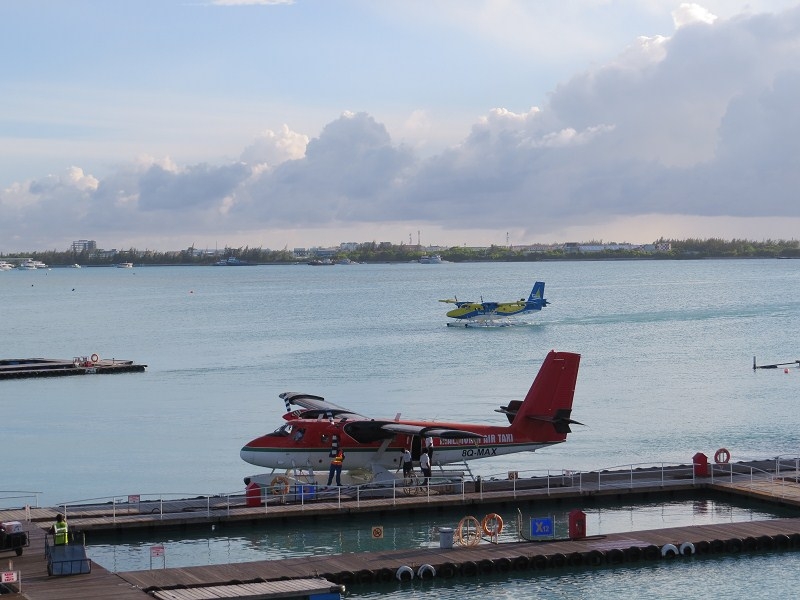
0, 238, 800, 266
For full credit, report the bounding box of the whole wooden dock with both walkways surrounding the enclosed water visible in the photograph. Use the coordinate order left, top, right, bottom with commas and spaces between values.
0, 461, 800, 600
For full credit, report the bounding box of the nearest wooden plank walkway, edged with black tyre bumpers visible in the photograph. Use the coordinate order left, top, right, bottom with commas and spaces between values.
112, 519, 800, 589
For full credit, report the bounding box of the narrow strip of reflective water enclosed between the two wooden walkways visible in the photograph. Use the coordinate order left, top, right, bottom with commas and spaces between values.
87, 499, 782, 571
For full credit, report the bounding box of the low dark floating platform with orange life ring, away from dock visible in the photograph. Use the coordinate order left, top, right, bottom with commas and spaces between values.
0, 354, 147, 379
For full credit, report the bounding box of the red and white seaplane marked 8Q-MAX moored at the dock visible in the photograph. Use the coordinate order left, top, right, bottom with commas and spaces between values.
241, 351, 580, 482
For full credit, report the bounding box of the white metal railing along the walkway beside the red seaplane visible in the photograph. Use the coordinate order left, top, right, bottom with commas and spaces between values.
40, 457, 800, 522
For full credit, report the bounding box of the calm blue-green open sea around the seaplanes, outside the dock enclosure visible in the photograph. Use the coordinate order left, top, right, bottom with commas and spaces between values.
0, 260, 800, 598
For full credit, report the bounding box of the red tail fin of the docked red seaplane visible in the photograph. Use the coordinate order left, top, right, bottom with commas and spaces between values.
506, 350, 581, 441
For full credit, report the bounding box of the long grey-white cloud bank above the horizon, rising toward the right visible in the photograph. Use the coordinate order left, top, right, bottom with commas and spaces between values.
0, 5, 800, 248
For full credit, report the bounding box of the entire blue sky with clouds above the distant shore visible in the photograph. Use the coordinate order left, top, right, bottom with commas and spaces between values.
0, 0, 800, 253
